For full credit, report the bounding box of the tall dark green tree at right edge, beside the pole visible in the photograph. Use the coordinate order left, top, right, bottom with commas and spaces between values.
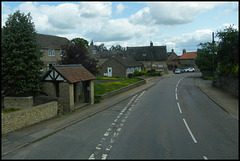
217, 26, 239, 76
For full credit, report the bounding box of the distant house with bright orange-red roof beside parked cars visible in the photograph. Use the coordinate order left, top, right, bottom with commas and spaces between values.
178, 49, 197, 68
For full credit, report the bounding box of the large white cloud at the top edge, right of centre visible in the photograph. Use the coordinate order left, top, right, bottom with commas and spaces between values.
130, 2, 217, 25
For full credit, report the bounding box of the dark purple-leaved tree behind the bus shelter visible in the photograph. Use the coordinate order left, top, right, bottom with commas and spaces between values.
59, 43, 98, 75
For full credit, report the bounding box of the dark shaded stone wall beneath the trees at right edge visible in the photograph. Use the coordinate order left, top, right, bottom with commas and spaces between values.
215, 76, 239, 97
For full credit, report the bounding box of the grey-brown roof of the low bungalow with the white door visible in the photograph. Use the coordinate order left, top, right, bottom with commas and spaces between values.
107, 55, 142, 67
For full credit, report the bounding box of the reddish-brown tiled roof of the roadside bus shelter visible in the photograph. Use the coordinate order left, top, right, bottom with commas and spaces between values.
53, 64, 96, 83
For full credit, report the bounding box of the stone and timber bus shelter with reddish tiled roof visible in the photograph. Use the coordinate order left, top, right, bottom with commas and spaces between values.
43, 64, 96, 111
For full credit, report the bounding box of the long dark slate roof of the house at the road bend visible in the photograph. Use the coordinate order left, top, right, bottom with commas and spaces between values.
124, 46, 168, 61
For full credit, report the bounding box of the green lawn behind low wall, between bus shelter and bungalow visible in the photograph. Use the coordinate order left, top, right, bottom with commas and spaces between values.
94, 77, 140, 95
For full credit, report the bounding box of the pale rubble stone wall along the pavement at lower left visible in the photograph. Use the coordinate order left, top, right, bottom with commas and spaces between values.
1, 101, 58, 134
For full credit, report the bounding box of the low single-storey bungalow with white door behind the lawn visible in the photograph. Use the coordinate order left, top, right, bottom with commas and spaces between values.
99, 55, 143, 77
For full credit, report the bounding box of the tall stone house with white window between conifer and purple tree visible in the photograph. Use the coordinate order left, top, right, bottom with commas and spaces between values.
37, 34, 71, 72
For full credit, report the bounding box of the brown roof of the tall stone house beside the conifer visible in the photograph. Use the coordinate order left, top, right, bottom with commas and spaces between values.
37, 34, 70, 49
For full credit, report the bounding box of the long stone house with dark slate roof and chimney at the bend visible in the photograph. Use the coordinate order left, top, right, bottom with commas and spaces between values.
124, 42, 168, 71
